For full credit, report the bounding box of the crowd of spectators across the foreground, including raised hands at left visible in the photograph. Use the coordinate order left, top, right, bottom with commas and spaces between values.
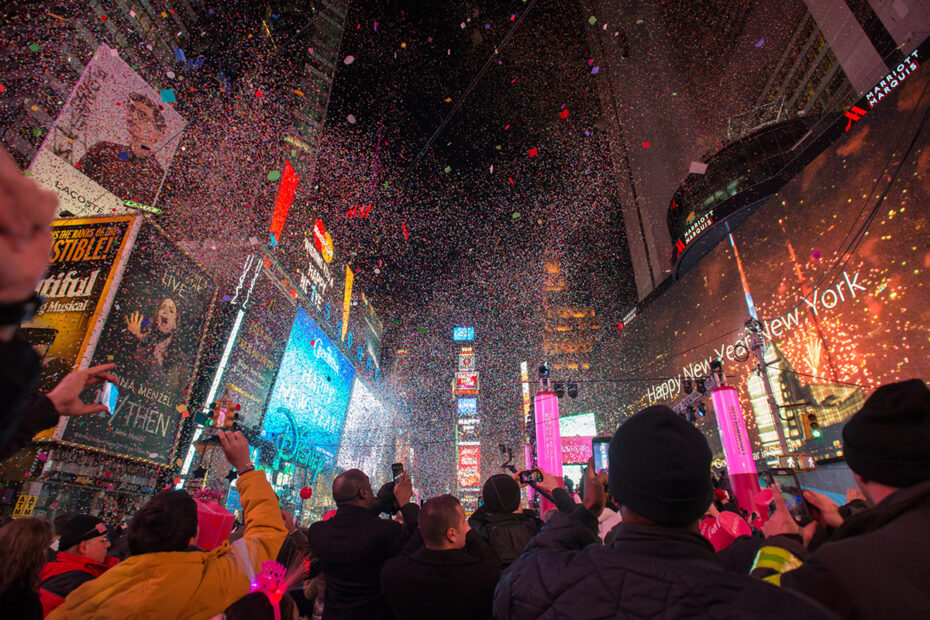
0, 151, 930, 620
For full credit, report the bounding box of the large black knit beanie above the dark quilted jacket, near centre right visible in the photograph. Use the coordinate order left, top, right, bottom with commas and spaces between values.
608, 405, 714, 525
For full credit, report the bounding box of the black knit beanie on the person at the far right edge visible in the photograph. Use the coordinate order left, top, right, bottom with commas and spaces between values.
843, 379, 930, 489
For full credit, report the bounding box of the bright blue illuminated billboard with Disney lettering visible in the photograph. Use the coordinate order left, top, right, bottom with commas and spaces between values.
262, 309, 355, 472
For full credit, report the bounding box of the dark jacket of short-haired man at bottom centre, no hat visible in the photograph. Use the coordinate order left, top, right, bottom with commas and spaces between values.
381, 530, 500, 620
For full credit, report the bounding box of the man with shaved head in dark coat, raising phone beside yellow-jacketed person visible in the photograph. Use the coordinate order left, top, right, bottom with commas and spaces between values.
307, 469, 419, 620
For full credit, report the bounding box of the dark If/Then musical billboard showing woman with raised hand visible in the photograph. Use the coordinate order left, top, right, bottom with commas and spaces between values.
62, 222, 216, 465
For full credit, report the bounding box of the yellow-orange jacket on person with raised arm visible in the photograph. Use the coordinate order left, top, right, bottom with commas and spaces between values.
47, 471, 287, 620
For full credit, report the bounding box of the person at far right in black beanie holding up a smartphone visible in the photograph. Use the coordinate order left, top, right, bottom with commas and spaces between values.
752, 379, 930, 618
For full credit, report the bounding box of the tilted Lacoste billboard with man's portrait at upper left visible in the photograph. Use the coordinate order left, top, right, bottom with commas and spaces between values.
32, 45, 187, 216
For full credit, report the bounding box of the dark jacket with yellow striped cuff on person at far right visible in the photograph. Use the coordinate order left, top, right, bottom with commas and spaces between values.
752, 481, 930, 618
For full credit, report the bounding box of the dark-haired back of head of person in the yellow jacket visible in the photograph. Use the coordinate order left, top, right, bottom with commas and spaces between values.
126, 489, 197, 555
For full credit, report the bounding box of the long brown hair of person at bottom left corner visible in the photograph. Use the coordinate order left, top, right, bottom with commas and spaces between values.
0, 517, 53, 593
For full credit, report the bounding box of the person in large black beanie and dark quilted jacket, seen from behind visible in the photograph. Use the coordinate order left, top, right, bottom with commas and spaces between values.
494, 406, 829, 620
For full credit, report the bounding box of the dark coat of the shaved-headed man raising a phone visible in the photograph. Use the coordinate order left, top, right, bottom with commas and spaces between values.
307, 503, 420, 620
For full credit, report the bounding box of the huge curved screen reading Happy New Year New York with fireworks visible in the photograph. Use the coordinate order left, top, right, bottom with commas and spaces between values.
605, 60, 930, 459
